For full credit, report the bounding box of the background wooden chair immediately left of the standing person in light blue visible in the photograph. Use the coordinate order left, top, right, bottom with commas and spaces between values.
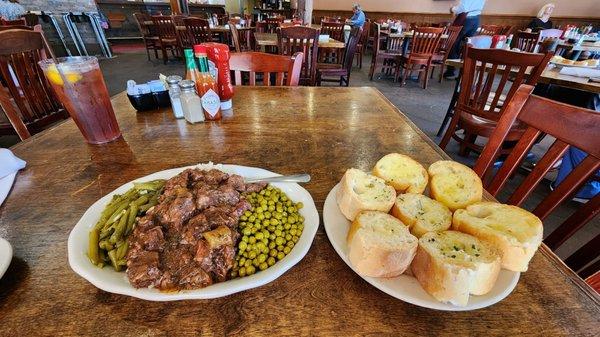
396, 27, 444, 89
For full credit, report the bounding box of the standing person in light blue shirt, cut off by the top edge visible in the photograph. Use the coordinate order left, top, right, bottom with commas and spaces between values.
444, 0, 485, 78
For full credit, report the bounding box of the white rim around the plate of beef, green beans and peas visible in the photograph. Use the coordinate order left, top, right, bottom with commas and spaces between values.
67, 162, 320, 302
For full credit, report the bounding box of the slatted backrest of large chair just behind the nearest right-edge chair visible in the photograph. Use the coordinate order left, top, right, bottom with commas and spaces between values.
456, 46, 551, 121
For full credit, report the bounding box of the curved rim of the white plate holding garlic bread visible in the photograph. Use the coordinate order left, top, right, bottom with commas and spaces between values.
323, 183, 521, 311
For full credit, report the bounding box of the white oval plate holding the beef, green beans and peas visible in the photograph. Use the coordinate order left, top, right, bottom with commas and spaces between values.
68, 164, 319, 301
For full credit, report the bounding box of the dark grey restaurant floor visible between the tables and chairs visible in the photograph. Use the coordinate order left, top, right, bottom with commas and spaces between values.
0, 51, 600, 258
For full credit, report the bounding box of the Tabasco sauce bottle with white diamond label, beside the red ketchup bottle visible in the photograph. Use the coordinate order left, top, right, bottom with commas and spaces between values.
194, 45, 222, 121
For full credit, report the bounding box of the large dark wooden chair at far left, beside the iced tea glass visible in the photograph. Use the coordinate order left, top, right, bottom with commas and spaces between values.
0, 29, 69, 140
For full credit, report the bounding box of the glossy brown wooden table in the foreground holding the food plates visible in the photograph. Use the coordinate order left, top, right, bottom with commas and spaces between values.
0, 87, 600, 336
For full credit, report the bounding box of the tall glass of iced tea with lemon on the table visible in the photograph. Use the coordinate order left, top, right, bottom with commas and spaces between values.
39, 56, 121, 144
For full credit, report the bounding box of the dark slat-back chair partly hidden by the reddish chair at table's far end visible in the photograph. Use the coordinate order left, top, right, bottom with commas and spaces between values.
277, 26, 319, 86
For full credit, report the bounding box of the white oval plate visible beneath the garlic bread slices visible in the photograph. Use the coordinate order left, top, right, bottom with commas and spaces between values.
323, 184, 520, 311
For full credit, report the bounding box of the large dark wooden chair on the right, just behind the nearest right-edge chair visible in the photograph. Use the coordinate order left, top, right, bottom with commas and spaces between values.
440, 46, 551, 156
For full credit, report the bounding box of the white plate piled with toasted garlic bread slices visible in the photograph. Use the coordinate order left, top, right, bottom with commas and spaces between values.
323, 153, 543, 311
